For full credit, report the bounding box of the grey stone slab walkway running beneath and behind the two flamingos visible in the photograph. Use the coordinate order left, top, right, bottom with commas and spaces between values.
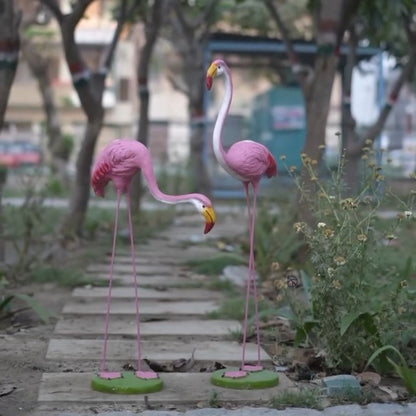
33, 215, 416, 416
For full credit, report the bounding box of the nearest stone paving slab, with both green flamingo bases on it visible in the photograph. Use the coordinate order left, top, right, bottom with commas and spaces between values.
38, 373, 294, 405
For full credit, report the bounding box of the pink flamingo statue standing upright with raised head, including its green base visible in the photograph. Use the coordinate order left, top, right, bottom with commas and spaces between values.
206, 59, 278, 388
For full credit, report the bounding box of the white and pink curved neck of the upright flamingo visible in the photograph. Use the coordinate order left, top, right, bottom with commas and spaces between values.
212, 64, 233, 174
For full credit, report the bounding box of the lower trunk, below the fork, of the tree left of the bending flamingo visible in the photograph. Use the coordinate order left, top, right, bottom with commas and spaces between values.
61, 112, 104, 237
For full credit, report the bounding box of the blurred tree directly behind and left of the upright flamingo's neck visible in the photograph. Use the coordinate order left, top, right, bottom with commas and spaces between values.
163, 0, 221, 195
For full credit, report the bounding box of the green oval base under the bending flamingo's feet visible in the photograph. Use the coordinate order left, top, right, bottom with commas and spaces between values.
91, 372, 163, 394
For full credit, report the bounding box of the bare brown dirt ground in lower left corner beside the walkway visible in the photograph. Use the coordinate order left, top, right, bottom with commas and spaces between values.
0, 283, 71, 416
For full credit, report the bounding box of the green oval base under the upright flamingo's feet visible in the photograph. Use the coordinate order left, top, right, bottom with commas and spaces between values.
211, 368, 279, 390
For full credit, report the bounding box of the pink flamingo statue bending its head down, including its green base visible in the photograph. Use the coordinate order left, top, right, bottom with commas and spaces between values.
91, 139, 215, 393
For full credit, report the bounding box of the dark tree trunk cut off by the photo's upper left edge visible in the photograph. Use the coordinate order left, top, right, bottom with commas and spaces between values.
0, 0, 22, 131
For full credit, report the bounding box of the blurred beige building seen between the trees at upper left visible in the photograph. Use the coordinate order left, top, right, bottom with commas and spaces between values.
0, 0, 187, 171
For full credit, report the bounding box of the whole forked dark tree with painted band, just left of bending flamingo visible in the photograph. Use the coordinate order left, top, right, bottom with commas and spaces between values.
41, 0, 140, 238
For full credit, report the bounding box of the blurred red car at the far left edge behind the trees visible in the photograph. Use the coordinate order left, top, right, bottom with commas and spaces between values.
0, 141, 42, 168
